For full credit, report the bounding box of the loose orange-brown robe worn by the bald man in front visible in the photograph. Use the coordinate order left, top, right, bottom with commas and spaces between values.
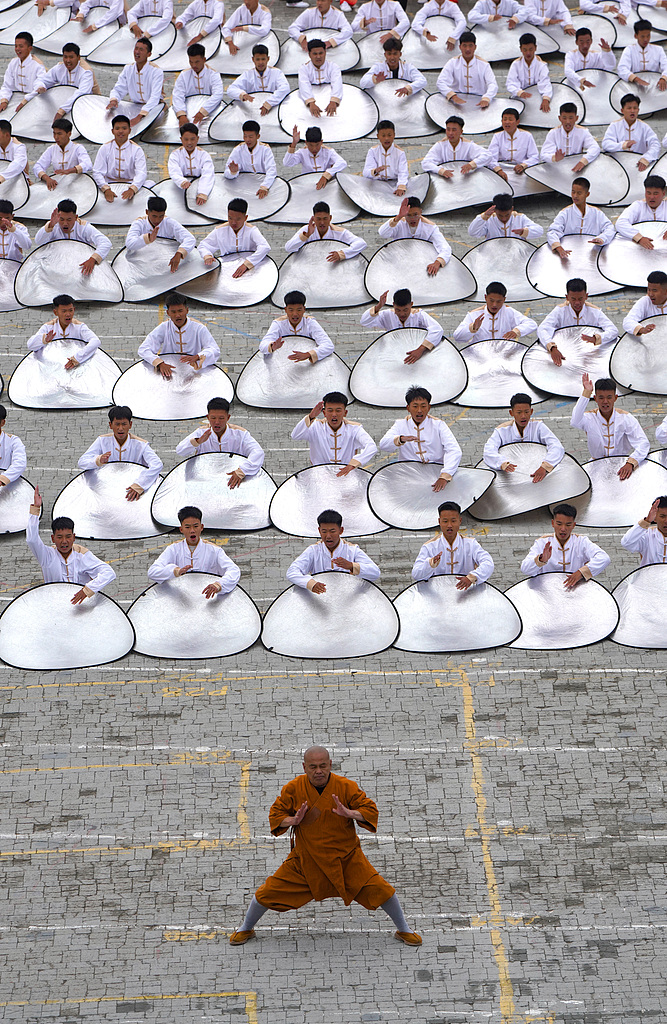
255, 772, 395, 911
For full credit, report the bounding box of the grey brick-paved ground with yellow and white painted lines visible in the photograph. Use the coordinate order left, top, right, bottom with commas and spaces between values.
0, 0, 667, 1024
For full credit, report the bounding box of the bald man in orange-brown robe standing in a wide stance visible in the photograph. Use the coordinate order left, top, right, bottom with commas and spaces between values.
230, 746, 421, 946
